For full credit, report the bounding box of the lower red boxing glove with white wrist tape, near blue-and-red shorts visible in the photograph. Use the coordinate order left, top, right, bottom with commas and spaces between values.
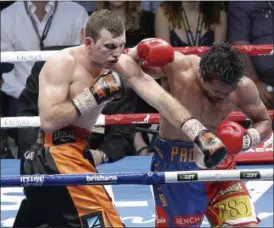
217, 120, 260, 154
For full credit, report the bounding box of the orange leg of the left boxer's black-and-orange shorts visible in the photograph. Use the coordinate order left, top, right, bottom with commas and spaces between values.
49, 143, 124, 227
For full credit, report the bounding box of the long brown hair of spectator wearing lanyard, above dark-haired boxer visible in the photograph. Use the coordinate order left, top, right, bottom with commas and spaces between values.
161, 1, 225, 28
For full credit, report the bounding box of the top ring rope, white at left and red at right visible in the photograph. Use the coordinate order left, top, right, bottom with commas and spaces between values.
1, 44, 273, 62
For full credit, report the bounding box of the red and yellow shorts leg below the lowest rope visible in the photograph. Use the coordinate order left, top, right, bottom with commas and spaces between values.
206, 181, 260, 227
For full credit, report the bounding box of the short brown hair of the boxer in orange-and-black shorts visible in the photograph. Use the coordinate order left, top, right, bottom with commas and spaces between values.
85, 9, 125, 40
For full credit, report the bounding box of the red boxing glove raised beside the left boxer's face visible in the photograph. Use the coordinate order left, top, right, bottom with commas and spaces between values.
137, 38, 174, 67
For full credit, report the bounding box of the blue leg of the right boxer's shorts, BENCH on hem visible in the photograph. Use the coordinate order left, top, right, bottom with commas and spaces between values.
151, 140, 208, 227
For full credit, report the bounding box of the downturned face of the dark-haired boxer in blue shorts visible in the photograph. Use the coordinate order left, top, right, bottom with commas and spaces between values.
201, 79, 235, 102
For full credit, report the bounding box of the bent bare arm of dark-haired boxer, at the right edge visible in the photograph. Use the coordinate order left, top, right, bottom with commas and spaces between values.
237, 77, 272, 141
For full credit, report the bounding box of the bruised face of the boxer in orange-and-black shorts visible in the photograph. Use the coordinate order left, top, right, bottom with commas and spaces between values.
86, 29, 126, 68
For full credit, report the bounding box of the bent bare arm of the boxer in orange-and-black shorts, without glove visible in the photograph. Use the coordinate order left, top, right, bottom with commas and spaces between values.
38, 55, 79, 132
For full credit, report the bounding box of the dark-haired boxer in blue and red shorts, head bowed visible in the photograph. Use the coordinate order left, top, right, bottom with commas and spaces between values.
127, 43, 271, 227
